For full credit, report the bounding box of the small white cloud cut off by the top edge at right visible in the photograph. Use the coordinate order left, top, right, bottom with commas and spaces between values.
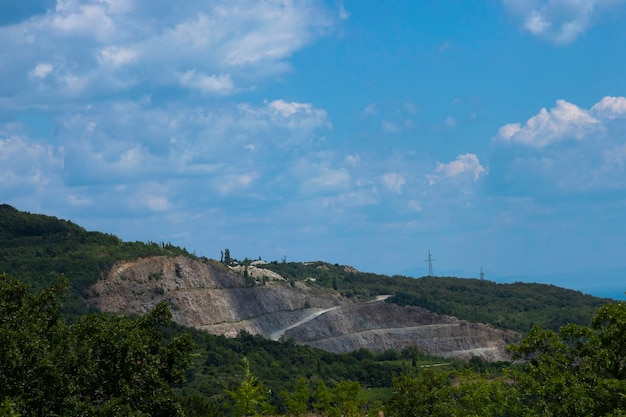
502, 0, 624, 45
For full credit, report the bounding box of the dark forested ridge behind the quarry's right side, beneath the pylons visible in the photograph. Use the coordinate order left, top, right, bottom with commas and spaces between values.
260, 262, 609, 332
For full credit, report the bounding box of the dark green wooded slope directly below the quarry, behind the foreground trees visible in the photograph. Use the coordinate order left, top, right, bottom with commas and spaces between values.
168, 326, 468, 412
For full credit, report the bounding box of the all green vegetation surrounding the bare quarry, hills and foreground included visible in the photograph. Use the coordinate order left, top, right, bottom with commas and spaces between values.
0, 205, 626, 417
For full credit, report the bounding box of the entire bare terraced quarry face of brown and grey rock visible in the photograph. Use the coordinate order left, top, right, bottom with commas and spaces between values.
88, 257, 516, 360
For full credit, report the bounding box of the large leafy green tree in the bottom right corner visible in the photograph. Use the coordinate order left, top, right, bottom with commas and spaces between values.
510, 301, 626, 417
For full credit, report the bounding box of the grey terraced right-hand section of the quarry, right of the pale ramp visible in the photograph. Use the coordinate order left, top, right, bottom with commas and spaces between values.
283, 302, 516, 361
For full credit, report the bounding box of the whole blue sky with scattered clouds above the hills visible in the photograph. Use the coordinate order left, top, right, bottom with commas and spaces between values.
0, 0, 626, 297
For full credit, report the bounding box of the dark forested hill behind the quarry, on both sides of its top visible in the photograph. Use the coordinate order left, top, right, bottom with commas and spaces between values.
0, 204, 608, 332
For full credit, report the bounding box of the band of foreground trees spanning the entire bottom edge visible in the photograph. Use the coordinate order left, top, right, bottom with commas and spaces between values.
0, 275, 626, 417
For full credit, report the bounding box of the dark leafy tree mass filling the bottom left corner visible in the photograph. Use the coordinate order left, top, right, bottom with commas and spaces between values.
0, 275, 193, 416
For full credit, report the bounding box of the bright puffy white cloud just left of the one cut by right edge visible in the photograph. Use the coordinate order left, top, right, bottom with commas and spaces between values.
495, 100, 602, 148
